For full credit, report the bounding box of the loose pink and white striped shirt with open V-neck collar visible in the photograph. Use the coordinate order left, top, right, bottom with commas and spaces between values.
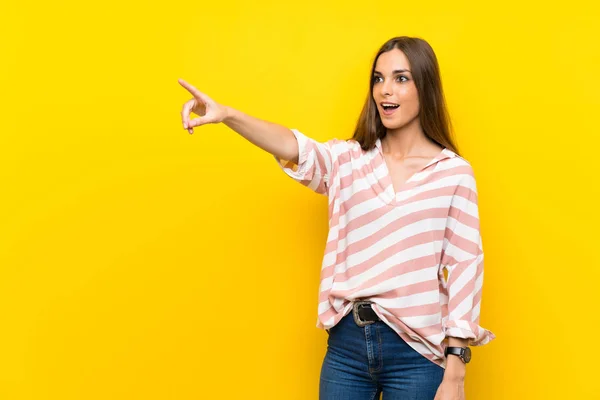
275, 129, 495, 368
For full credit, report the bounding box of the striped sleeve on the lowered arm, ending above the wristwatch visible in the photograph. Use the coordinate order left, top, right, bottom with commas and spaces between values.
440, 168, 495, 346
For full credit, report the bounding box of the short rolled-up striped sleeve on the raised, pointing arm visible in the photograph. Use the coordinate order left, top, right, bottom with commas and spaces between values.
275, 129, 338, 196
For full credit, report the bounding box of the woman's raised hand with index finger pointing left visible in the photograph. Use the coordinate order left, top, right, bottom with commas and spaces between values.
178, 79, 227, 134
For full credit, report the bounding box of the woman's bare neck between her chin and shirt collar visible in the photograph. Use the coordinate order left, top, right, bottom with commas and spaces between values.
381, 117, 431, 158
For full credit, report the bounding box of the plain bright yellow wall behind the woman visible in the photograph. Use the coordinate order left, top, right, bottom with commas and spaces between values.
0, 0, 600, 400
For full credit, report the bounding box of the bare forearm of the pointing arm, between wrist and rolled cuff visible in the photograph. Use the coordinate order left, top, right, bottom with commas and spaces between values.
223, 107, 298, 163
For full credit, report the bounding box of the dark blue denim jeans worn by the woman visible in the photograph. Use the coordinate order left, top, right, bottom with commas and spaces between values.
319, 312, 444, 400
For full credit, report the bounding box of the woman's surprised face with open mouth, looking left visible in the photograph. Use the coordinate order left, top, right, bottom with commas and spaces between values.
373, 49, 419, 129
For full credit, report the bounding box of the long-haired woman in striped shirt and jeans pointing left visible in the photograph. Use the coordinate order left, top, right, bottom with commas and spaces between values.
179, 36, 495, 400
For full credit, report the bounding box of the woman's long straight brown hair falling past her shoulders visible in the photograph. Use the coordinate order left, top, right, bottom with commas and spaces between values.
352, 36, 458, 154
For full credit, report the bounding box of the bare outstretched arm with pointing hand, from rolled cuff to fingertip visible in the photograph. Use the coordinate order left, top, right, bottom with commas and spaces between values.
179, 79, 299, 163
